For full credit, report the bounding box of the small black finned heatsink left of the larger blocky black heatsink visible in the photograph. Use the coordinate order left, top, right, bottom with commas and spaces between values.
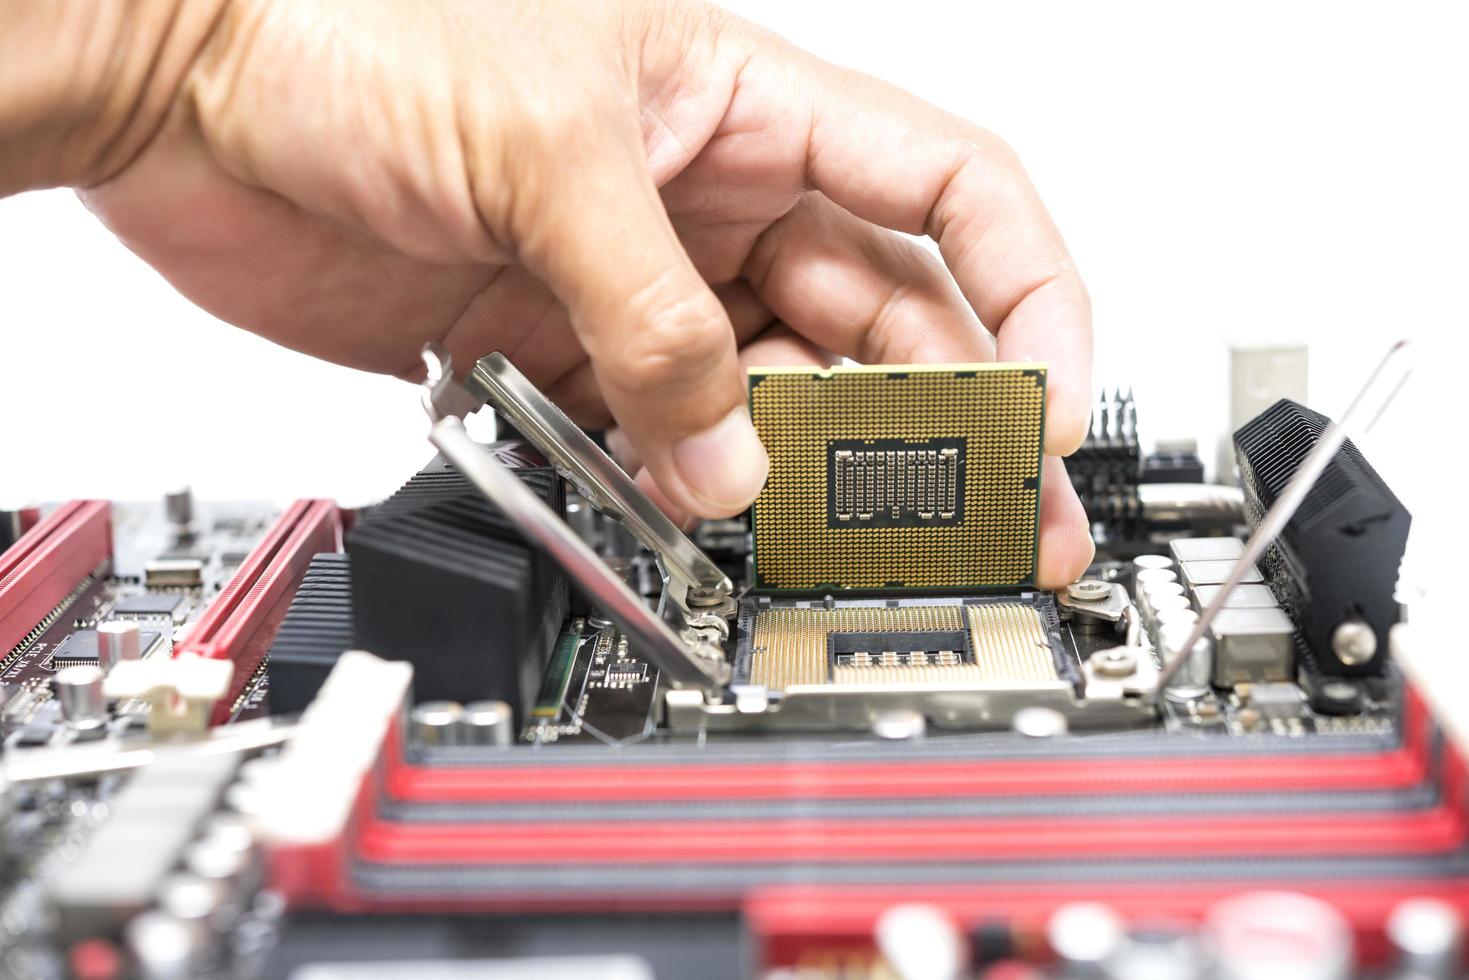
269, 552, 355, 714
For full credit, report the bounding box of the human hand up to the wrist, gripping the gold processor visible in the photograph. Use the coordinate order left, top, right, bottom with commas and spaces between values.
11, 0, 1091, 585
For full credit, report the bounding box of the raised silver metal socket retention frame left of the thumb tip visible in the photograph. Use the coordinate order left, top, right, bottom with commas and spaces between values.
423, 344, 733, 692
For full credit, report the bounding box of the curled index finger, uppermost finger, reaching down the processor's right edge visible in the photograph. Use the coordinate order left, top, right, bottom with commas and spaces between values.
746, 48, 1091, 455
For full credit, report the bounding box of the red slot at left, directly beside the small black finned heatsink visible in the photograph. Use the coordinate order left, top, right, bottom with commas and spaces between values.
173, 500, 342, 724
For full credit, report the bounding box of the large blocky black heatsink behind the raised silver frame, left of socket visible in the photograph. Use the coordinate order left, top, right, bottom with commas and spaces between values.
347, 444, 567, 718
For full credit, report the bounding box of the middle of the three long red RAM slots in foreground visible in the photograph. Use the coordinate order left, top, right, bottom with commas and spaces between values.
357, 805, 1466, 864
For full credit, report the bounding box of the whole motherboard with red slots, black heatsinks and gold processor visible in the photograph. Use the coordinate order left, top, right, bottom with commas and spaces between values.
0, 350, 1451, 980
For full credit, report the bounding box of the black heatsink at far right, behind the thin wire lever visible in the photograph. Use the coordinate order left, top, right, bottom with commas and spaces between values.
1234, 398, 1410, 674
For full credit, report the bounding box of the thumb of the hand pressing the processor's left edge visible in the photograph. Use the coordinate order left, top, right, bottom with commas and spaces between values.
523, 138, 770, 517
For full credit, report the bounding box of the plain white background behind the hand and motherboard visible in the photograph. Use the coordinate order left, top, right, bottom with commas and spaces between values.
0, 0, 1469, 614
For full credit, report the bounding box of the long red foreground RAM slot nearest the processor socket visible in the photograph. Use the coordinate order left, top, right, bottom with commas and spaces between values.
386, 693, 1432, 802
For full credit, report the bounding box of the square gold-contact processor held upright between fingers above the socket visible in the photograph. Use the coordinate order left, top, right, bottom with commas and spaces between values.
749, 364, 1046, 592
